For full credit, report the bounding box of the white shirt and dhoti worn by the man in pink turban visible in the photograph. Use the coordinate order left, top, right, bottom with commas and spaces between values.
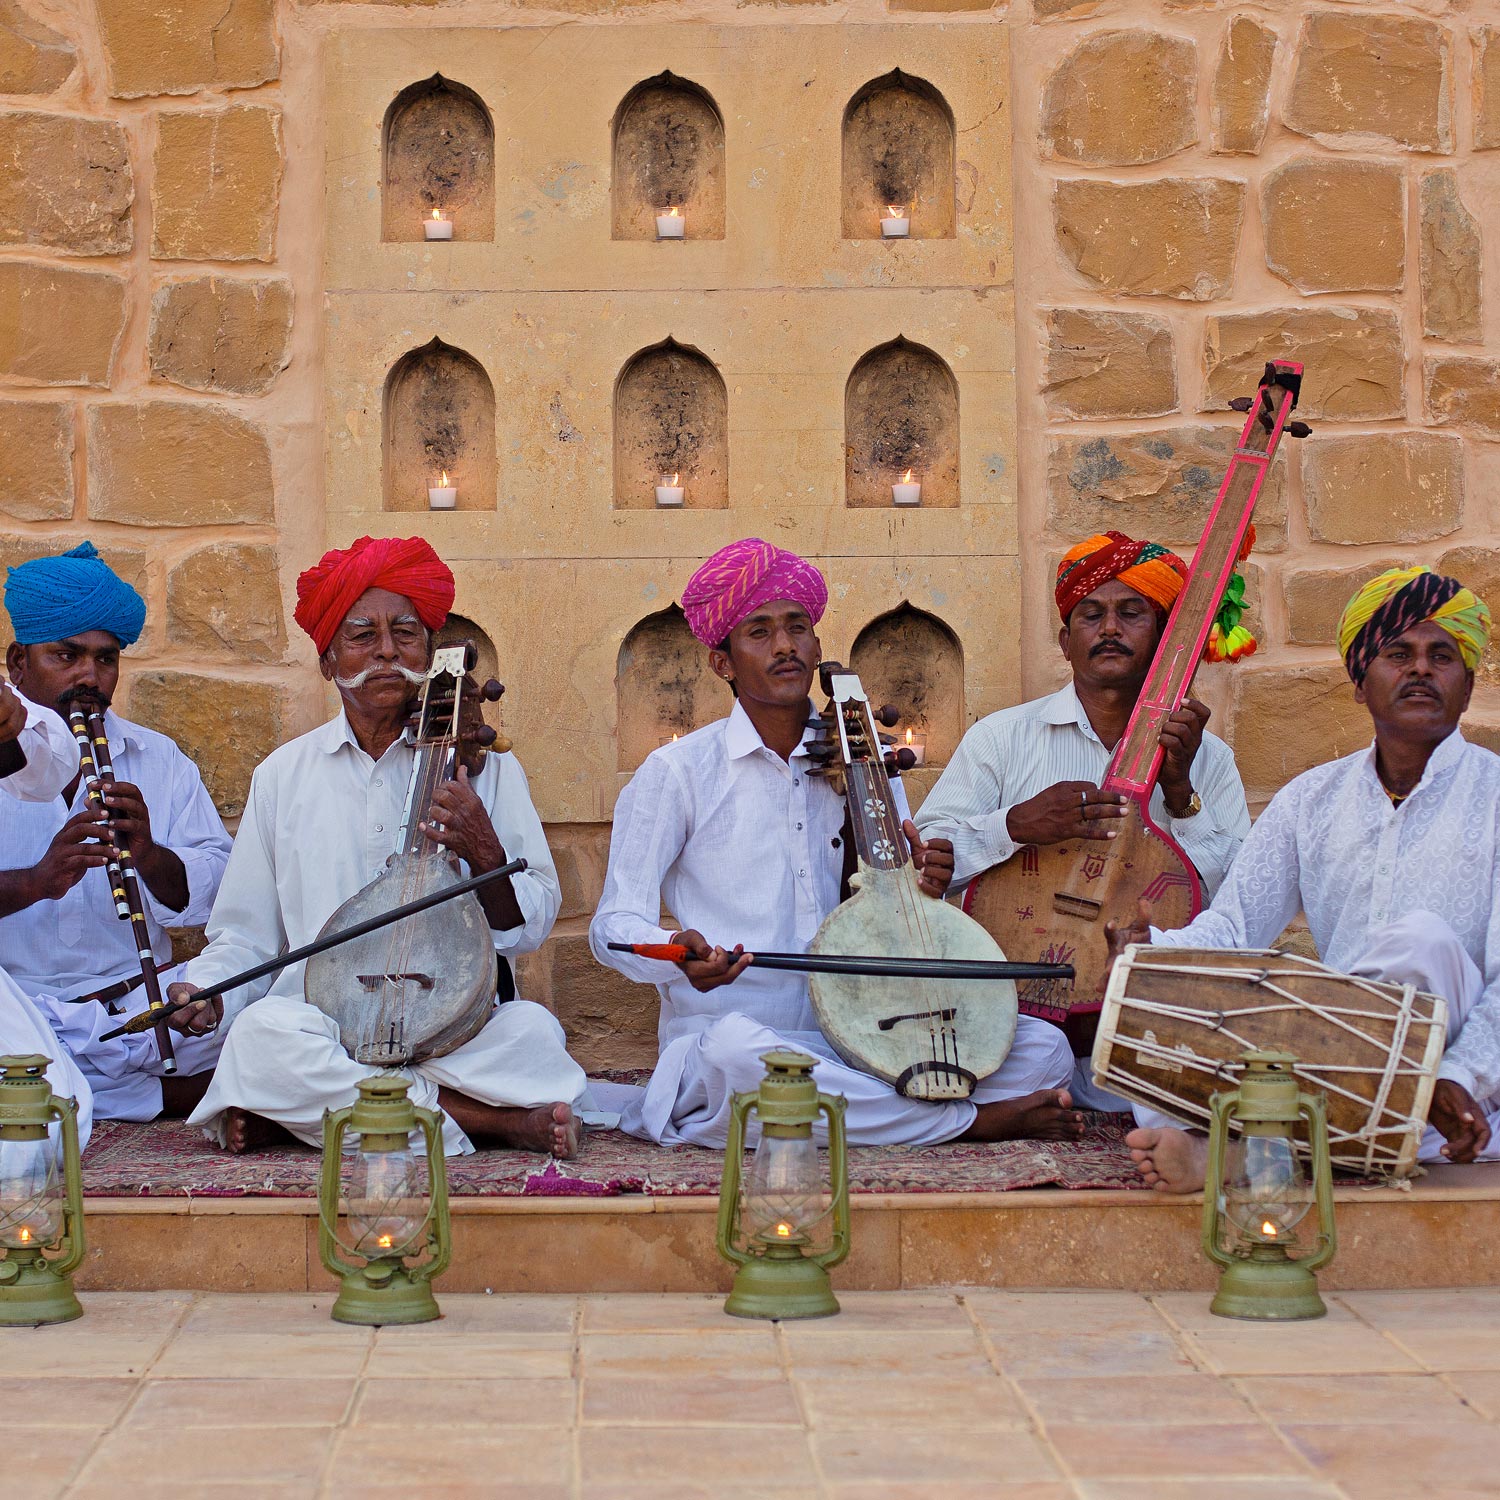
588, 704, 1073, 1146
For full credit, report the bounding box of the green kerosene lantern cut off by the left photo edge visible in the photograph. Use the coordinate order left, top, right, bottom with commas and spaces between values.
0, 1053, 84, 1326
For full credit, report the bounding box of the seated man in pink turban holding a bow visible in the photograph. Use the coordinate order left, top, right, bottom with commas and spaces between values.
590, 537, 1082, 1148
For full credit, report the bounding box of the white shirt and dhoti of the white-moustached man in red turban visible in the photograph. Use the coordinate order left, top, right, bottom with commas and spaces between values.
185, 713, 587, 1155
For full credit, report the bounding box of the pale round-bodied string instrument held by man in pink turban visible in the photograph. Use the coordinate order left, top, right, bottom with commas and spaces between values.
809, 662, 1016, 1100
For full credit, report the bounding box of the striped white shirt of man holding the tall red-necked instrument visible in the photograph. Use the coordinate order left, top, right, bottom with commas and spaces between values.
917, 683, 1250, 894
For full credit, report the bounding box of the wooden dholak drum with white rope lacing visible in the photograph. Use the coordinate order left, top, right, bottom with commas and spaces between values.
1094, 944, 1448, 1176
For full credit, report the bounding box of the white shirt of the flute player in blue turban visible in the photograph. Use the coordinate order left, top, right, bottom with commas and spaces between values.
0, 710, 230, 999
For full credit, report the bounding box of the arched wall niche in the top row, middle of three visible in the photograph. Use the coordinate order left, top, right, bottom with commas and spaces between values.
611, 74, 725, 240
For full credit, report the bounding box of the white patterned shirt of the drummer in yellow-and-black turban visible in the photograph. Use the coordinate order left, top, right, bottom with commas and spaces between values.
1152, 729, 1500, 1100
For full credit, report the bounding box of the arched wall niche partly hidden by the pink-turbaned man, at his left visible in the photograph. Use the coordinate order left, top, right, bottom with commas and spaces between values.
615, 605, 731, 771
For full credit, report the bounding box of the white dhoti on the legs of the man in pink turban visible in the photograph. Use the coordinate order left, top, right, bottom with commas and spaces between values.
620, 1013, 1073, 1149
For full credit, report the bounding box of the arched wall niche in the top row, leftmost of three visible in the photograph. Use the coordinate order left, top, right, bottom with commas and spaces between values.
381, 74, 495, 245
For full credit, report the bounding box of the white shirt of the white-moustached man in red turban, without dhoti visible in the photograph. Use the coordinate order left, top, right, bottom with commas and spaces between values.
183, 711, 563, 1014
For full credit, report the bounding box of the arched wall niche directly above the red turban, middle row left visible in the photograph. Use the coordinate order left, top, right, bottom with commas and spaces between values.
384, 339, 495, 510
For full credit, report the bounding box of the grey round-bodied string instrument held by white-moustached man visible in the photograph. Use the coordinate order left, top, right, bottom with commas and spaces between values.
303, 644, 510, 1068
